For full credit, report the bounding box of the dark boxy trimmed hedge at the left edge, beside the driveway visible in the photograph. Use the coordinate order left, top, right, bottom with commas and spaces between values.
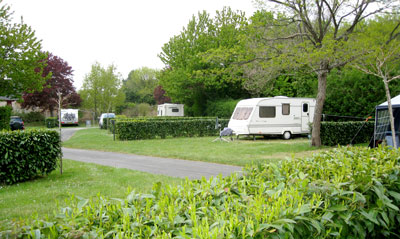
0, 130, 61, 184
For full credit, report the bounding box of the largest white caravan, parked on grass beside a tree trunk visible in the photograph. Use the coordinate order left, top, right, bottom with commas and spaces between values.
228, 96, 316, 139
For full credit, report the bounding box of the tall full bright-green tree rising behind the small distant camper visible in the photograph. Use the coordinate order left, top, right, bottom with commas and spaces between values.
159, 8, 247, 115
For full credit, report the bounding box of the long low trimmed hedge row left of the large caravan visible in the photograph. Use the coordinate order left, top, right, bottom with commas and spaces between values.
115, 119, 229, 140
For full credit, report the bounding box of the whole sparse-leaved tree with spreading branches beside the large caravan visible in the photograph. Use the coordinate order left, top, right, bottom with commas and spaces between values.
250, 0, 398, 146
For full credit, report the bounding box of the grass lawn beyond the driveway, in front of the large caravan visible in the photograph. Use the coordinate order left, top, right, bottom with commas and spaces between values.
63, 128, 324, 166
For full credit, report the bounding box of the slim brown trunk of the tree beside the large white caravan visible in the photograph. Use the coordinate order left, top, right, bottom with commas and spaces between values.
311, 66, 329, 147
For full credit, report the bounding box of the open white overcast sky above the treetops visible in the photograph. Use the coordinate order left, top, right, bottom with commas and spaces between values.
3, 0, 256, 90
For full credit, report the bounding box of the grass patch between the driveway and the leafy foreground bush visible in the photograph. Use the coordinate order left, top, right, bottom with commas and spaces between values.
0, 160, 182, 222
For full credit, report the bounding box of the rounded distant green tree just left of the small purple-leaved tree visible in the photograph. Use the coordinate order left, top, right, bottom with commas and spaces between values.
122, 67, 158, 105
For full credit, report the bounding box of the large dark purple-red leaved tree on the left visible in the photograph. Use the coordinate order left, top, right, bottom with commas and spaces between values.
21, 53, 82, 116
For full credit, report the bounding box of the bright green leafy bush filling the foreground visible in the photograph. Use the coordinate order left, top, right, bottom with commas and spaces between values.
0, 148, 400, 238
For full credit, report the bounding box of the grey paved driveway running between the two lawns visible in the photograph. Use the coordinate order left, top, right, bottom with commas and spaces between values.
61, 128, 242, 179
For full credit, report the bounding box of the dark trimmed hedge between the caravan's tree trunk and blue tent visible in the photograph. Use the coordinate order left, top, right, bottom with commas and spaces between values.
321, 121, 374, 146
